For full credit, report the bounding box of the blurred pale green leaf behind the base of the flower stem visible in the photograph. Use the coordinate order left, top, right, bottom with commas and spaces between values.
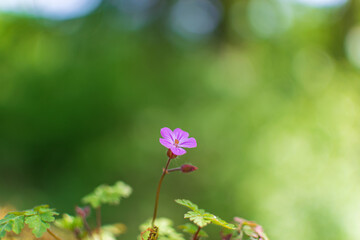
138, 218, 185, 240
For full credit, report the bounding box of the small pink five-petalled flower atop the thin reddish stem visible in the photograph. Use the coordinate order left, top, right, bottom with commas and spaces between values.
160, 127, 197, 155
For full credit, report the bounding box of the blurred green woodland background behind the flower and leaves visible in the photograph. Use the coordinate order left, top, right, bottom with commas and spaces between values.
0, 0, 360, 240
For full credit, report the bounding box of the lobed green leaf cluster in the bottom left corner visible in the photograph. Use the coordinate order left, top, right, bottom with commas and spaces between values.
0, 205, 58, 238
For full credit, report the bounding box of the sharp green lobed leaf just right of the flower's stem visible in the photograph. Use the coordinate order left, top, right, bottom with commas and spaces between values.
175, 199, 235, 229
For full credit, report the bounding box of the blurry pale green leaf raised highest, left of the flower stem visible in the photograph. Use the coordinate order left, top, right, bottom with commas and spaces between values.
82, 182, 132, 208
